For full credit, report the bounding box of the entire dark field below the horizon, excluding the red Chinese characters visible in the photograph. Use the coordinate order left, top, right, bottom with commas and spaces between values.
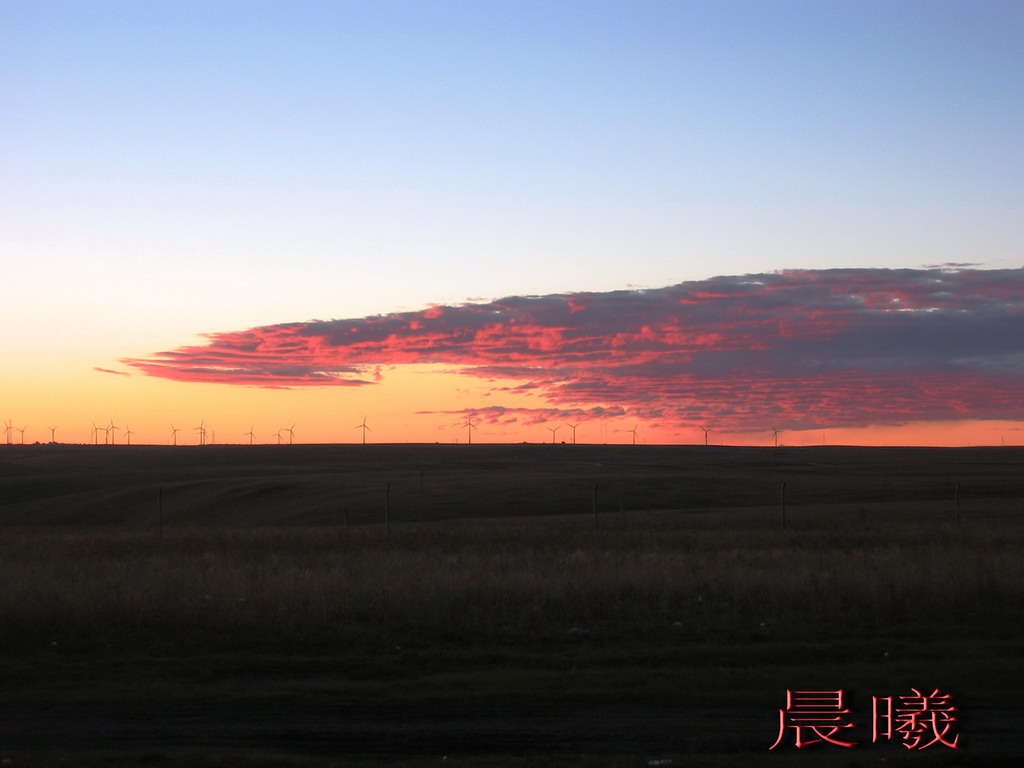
0, 445, 1024, 768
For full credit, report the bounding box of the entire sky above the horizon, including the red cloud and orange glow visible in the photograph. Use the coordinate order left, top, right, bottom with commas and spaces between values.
0, 0, 1024, 445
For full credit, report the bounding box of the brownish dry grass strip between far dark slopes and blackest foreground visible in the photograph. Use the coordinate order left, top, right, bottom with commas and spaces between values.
0, 510, 1024, 648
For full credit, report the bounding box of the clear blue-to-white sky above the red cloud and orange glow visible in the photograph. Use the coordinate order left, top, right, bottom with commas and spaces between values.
0, 0, 1024, 444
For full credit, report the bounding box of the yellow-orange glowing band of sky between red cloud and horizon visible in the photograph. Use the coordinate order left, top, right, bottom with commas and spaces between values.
0, 366, 1024, 446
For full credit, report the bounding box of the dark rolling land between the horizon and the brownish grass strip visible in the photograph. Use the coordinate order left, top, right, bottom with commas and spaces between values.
0, 444, 1024, 527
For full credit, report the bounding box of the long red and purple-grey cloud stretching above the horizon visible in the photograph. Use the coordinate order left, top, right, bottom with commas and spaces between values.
123, 269, 1024, 429
